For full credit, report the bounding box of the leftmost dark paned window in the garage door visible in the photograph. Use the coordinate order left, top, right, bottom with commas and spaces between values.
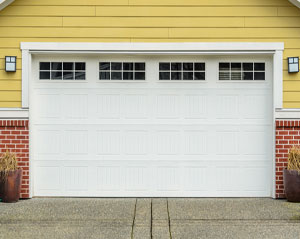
40, 62, 85, 80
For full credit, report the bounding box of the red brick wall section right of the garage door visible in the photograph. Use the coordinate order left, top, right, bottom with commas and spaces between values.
276, 120, 300, 198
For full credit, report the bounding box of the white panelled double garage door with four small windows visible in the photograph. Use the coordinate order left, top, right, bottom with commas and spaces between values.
30, 55, 272, 197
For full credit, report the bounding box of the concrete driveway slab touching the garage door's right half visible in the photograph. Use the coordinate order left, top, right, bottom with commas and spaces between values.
169, 198, 300, 220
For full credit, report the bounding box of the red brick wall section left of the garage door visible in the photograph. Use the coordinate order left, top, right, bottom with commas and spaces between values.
0, 120, 29, 198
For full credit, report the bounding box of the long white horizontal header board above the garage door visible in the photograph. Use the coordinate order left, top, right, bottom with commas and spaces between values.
21, 42, 284, 53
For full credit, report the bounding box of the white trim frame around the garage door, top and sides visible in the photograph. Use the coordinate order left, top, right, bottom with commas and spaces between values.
21, 42, 284, 198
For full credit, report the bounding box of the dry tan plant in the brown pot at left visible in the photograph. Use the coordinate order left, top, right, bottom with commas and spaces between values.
0, 151, 18, 181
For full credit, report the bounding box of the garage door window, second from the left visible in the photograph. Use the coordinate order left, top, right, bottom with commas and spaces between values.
99, 62, 146, 81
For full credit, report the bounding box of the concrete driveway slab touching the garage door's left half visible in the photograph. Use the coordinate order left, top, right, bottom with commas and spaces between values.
0, 198, 136, 223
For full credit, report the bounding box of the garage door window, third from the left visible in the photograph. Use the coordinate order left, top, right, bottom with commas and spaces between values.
159, 62, 205, 81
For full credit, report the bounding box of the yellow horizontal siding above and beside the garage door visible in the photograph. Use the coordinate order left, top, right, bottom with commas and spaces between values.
0, 0, 300, 108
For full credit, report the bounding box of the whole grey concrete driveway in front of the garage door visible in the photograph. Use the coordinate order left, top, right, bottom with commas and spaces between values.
0, 198, 300, 239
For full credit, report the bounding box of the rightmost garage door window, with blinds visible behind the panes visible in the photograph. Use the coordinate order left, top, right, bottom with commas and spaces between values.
219, 62, 265, 81
